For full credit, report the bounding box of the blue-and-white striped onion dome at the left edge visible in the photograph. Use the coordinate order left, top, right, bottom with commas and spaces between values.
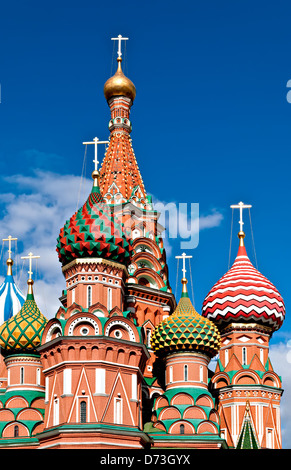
0, 258, 25, 325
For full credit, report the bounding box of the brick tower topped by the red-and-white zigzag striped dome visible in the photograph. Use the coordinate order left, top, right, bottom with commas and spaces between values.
203, 204, 285, 449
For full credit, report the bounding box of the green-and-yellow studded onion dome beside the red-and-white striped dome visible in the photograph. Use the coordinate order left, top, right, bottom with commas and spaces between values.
151, 278, 220, 358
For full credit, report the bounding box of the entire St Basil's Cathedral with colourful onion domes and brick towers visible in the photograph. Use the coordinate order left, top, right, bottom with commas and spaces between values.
0, 36, 285, 450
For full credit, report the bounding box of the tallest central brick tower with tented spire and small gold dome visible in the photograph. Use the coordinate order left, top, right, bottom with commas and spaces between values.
100, 42, 176, 388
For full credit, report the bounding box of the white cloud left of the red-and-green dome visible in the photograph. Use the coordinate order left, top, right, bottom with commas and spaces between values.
0, 170, 92, 318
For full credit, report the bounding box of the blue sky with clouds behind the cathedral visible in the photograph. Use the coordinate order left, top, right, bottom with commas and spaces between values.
0, 0, 291, 447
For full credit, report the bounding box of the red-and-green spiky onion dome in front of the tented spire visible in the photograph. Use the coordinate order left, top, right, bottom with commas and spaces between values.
57, 178, 132, 266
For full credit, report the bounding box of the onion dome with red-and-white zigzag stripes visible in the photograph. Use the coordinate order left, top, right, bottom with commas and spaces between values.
202, 232, 285, 331
